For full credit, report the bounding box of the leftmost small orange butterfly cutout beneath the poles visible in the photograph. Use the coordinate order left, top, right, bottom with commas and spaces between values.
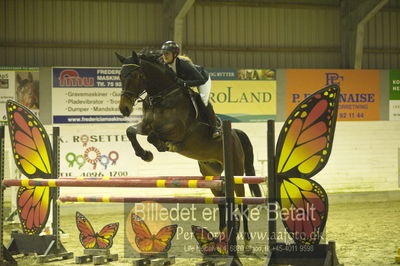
76, 212, 119, 249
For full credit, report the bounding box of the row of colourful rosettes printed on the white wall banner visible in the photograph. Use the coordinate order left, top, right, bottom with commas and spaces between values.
65, 147, 119, 169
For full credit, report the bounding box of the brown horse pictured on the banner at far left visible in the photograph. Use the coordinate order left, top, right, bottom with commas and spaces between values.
15, 72, 39, 109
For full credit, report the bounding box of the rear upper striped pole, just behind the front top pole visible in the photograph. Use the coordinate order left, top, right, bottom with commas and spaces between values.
54, 176, 266, 184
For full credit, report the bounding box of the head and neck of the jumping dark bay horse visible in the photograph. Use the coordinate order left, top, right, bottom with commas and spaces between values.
115, 51, 177, 116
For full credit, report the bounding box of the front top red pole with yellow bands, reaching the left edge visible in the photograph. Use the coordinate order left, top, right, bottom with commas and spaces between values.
3, 179, 223, 190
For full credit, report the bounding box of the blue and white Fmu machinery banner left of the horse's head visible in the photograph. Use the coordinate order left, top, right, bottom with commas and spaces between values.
52, 67, 142, 124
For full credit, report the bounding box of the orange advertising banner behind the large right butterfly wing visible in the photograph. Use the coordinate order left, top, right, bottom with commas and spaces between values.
286, 69, 380, 121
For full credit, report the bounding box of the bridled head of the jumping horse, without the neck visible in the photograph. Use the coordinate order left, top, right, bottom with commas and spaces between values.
115, 52, 147, 116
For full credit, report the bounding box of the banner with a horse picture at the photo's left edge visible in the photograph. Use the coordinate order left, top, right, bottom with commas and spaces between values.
0, 67, 39, 120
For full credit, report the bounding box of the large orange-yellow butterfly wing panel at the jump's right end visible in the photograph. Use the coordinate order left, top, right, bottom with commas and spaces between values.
276, 85, 340, 245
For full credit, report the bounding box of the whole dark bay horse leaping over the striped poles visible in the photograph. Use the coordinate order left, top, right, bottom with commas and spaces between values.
116, 52, 261, 252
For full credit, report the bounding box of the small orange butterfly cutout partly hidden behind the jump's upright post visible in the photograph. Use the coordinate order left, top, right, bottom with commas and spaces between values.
192, 225, 228, 255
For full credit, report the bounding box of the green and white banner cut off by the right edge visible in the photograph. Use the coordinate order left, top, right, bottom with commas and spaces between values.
389, 70, 400, 120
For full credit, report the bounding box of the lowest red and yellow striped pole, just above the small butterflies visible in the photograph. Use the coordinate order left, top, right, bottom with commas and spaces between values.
59, 195, 266, 205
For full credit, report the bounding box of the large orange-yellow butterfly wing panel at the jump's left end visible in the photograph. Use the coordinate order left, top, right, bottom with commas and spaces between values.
6, 100, 53, 235
